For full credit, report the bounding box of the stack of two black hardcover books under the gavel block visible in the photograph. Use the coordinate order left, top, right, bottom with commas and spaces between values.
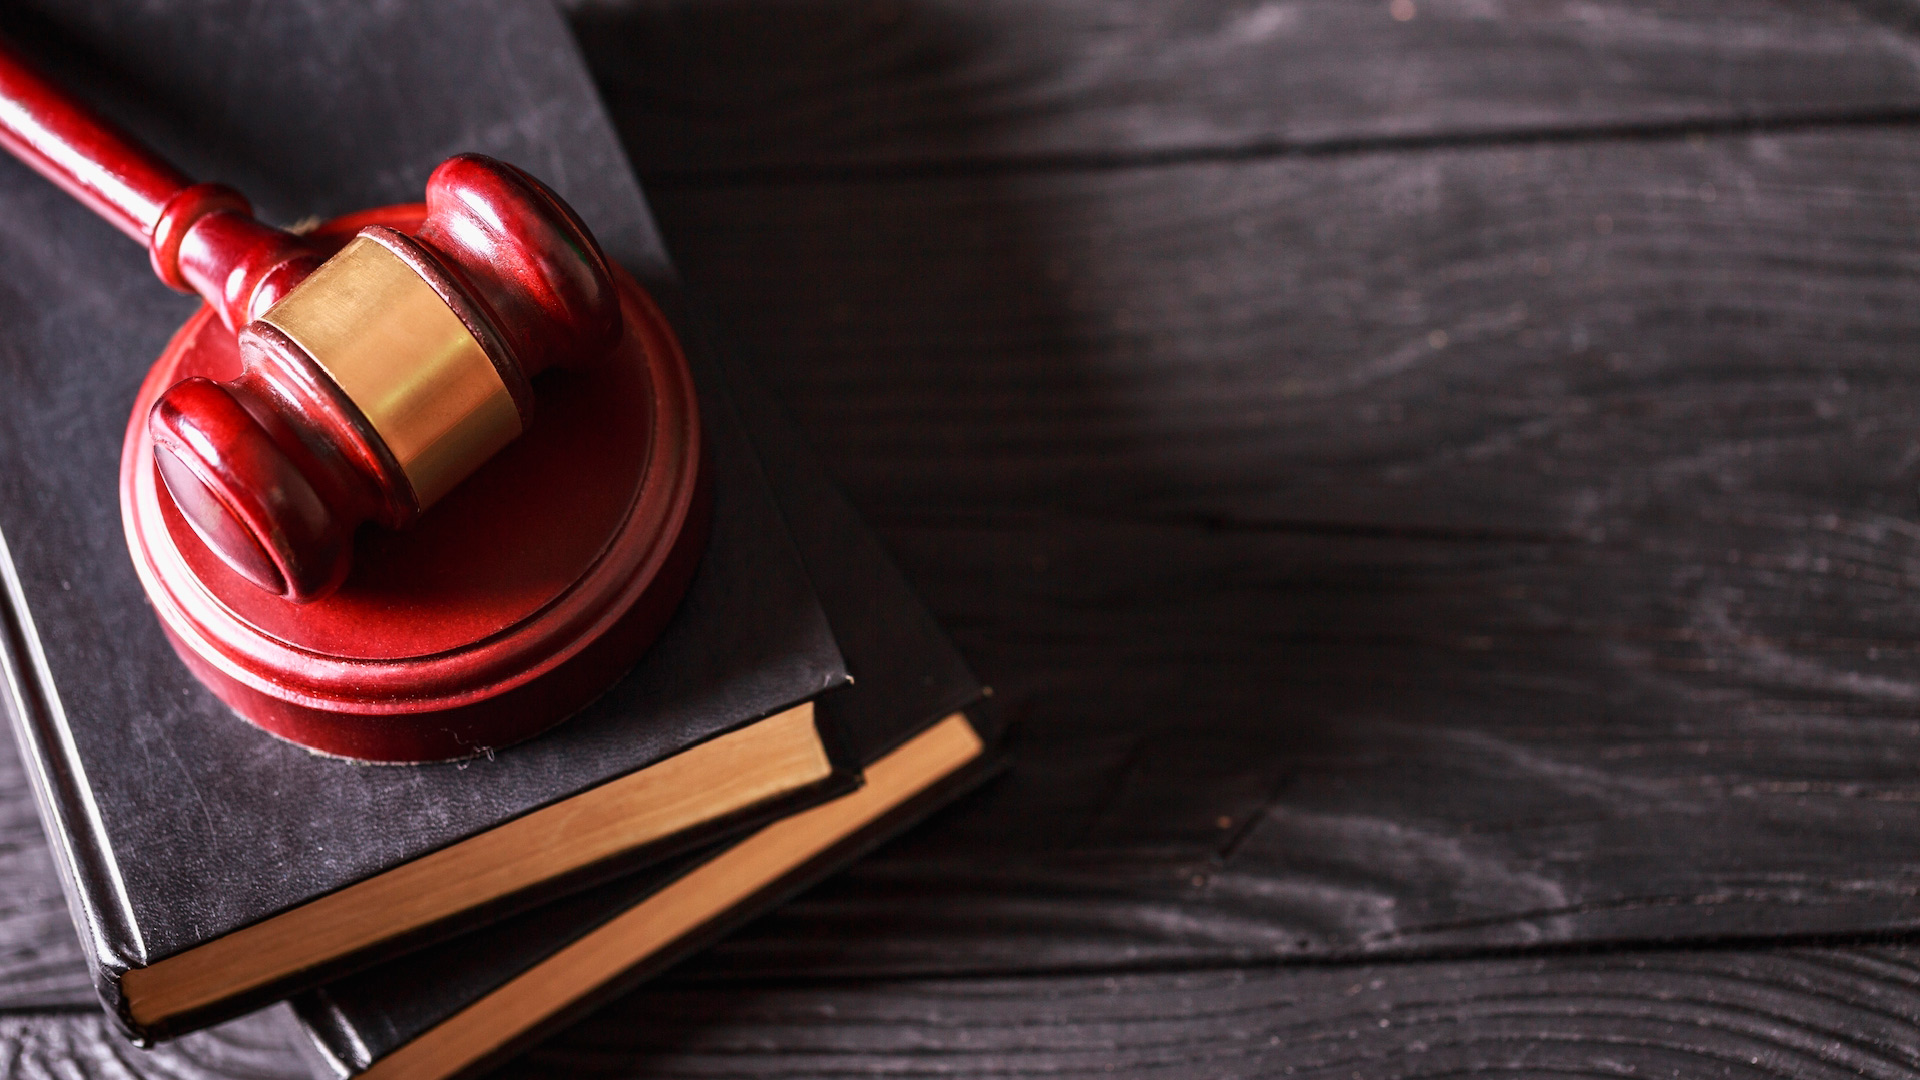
0, 0, 996, 1078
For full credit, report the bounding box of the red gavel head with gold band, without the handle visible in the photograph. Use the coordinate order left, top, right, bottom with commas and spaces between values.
148, 154, 620, 601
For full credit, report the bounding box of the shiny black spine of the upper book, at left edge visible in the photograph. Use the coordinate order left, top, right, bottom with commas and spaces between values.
0, 534, 148, 1045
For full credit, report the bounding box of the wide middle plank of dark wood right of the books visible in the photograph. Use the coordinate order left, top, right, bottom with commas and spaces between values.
637, 123, 1920, 974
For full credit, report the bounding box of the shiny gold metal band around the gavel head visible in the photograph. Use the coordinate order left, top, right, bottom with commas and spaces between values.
261, 236, 520, 509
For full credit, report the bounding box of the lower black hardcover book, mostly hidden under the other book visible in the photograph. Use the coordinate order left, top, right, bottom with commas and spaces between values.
292, 343, 998, 1080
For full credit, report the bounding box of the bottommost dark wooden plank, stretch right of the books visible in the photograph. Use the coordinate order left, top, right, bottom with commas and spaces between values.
518, 949, 1920, 1080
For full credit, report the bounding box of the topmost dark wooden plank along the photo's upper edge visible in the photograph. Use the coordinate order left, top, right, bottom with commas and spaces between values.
570, 0, 1920, 174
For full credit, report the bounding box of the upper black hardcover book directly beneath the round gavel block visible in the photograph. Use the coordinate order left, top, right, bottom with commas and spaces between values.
0, 0, 847, 1040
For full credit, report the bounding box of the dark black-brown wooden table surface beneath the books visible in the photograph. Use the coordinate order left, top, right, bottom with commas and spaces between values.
11, 0, 1920, 1078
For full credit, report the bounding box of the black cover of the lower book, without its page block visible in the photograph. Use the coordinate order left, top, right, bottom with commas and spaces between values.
292, 342, 998, 1078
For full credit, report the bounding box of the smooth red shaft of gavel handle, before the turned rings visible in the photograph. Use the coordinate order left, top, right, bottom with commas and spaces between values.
0, 42, 194, 246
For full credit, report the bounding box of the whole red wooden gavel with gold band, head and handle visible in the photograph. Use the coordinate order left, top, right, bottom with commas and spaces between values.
0, 35, 620, 601
